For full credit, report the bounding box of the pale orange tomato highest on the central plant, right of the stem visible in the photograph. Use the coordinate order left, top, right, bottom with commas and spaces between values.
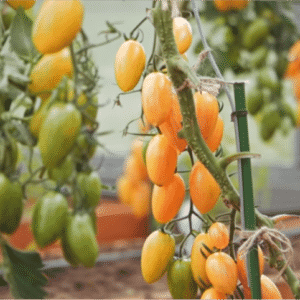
173, 17, 193, 54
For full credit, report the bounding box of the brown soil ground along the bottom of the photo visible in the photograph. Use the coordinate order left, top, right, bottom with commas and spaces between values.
0, 237, 300, 299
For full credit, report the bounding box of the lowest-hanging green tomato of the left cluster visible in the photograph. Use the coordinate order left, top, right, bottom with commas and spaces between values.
66, 213, 99, 267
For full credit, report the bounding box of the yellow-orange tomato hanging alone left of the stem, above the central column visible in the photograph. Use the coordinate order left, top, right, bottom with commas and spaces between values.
115, 40, 146, 92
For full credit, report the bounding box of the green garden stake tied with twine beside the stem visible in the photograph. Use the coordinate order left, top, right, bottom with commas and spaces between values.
232, 83, 261, 299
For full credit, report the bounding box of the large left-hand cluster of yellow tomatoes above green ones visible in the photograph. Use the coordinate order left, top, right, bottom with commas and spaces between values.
0, 0, 103, 267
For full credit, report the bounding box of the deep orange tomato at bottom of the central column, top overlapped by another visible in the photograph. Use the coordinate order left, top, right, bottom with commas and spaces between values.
152, 174, 185, 224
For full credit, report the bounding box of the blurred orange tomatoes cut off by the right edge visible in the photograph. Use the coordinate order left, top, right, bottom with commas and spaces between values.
285, 41, 300, 127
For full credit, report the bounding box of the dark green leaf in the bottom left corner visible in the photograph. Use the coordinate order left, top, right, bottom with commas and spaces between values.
2, 243, 47, 299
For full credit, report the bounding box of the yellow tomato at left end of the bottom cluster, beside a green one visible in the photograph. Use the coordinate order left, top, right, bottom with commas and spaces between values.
141, 230, 175, 283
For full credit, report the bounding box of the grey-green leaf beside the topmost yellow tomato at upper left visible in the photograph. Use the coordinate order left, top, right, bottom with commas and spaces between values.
10, 7, 38, 60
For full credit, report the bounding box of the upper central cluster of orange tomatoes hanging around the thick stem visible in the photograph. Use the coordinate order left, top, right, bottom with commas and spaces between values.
115, 17, 224, 220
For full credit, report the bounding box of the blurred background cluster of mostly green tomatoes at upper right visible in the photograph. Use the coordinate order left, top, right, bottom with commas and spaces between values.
195, 0, 298, 141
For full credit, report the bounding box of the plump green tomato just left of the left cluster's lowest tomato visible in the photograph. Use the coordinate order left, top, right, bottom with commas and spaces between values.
31, 191, 68, 248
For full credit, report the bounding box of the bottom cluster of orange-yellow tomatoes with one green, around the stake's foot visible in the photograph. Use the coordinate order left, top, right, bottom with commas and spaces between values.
141, 222, 282, 299
